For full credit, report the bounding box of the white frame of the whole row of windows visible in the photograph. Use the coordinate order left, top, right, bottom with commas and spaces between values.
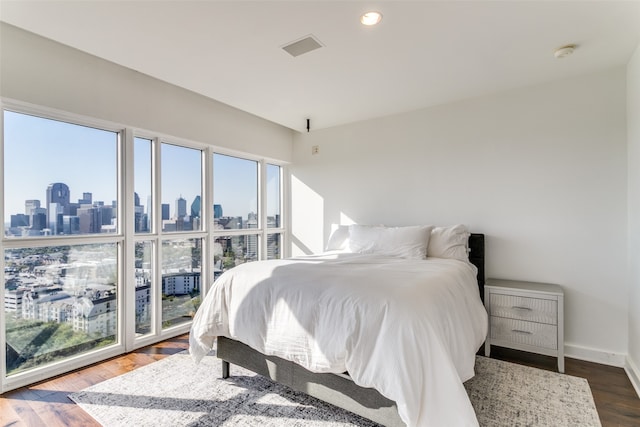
0, 98, 290, 393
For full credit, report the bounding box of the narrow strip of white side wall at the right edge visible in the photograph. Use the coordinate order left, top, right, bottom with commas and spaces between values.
627, 45, 640, 395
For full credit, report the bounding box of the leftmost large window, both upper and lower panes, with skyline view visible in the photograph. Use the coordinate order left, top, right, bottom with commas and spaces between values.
2, 110, 123, 377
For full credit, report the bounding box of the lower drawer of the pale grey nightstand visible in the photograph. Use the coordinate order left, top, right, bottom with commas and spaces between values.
491, 316, 558, 350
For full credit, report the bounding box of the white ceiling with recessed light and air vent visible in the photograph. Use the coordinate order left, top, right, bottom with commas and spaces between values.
0, 0, 640, 131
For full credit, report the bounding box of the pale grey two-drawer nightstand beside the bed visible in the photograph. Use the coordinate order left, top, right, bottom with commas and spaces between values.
484, 279, 564, 372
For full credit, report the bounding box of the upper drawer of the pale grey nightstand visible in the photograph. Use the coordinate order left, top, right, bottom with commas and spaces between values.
490, 292, 558, 325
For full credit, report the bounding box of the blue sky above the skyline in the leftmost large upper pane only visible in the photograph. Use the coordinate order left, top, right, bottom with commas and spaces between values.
3, 111, 117, 221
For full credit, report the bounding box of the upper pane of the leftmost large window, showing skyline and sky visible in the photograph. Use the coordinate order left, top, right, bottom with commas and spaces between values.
3, 110, 120, 238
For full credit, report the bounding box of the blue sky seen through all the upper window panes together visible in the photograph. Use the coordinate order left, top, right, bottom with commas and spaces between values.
3, 111, 279, 222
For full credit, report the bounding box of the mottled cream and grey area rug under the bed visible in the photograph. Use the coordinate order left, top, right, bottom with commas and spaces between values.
69, 352, 600, 427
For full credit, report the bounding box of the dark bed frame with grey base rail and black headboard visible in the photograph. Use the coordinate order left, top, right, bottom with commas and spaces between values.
216, 233, 485, 427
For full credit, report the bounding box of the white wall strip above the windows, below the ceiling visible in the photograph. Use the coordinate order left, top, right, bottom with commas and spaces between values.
0, 23, 293, 161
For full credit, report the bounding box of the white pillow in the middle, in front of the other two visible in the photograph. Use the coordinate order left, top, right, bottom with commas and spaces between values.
349, 225, 433, 259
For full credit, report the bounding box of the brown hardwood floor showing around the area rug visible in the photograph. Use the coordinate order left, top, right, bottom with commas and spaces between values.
0, 335, 640, 427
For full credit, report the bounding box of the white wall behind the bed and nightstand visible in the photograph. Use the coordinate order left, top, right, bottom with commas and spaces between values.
292, 68, 629, 366
